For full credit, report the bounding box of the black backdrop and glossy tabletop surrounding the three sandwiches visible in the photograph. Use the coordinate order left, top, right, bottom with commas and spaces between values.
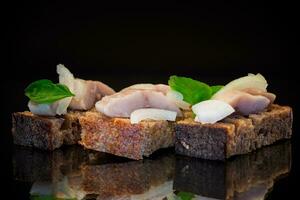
0, 1, 299, 199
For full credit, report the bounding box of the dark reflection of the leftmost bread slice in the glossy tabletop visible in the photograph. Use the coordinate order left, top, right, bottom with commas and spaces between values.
13, 145, 89, 182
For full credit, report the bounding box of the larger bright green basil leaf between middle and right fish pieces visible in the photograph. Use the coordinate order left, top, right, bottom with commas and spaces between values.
168, 76, 212, 104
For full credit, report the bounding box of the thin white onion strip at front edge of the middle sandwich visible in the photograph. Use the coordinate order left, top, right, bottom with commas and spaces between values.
130, 108, 177, 124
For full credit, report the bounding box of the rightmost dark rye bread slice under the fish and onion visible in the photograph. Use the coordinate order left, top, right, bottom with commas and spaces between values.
175, 104, 293, 160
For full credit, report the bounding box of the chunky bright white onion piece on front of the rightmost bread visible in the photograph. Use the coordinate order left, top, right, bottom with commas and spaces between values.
192, 100, 235, 124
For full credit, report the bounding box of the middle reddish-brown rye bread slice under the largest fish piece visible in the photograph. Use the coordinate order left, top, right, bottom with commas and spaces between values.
79, 111, 175, 160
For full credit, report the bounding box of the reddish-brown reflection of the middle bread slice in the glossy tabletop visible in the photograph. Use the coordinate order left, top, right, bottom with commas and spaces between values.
81, 155, 175, 199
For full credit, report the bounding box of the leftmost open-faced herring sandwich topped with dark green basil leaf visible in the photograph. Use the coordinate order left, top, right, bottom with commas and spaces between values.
12, 65, 115, 150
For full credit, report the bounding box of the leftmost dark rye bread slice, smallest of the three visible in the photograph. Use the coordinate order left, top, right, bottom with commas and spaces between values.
12, 111, 83, 150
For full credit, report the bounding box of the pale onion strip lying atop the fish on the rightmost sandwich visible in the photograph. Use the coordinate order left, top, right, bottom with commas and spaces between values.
212, 74, 268, 99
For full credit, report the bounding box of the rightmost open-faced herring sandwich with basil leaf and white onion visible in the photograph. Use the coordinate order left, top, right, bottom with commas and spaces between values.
170, 74, 293, 160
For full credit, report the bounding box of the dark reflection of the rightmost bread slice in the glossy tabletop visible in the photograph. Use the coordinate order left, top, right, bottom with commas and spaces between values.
174, 141, 291, 200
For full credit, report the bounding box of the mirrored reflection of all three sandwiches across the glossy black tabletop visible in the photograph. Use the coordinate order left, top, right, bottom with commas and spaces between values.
13, 141, 291, 200
